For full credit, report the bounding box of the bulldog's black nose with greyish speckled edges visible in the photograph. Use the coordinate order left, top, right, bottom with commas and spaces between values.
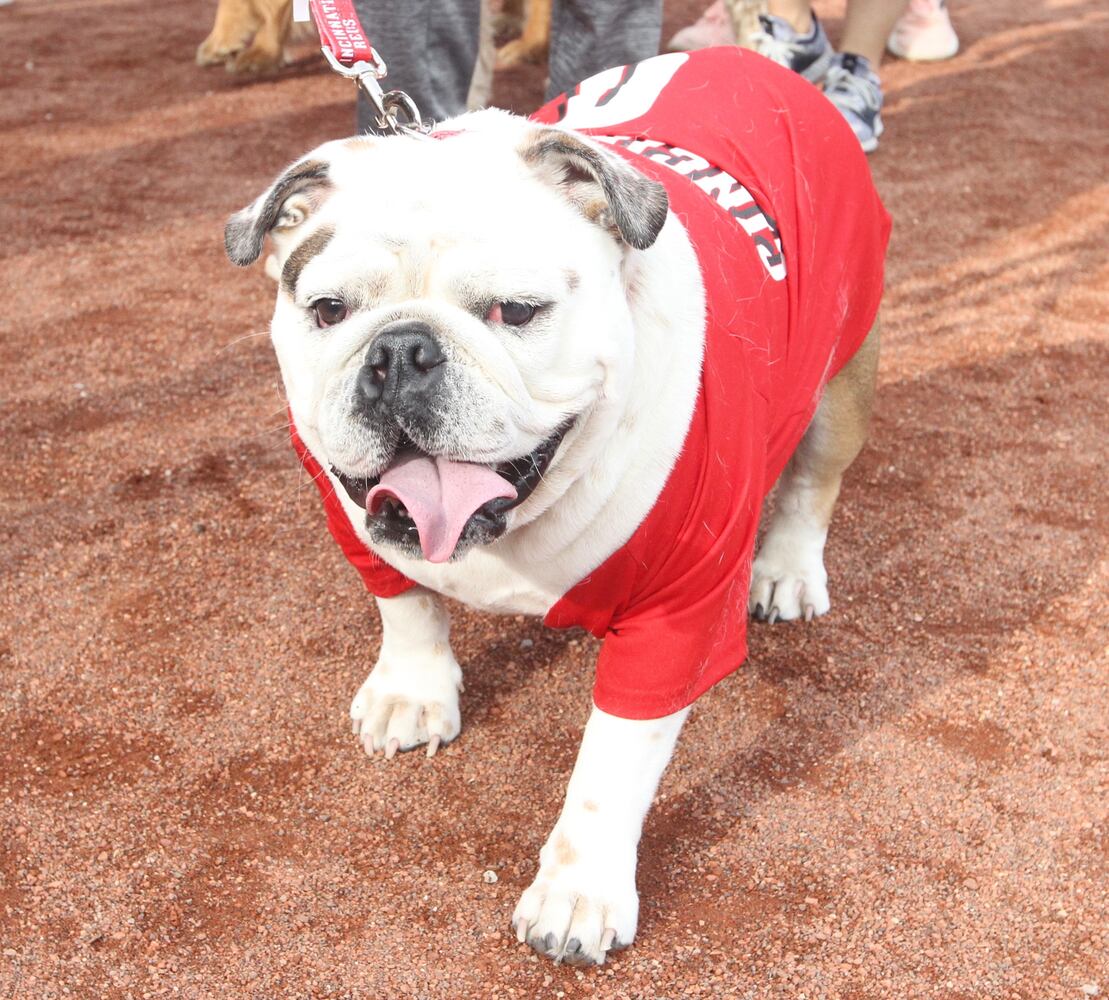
356, 319, 447, 408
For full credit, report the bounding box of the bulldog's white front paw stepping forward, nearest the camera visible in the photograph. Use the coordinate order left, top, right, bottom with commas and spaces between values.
512, 830, 639, 966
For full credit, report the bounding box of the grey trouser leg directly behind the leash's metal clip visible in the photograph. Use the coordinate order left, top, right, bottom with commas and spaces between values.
355, 0, 481, 132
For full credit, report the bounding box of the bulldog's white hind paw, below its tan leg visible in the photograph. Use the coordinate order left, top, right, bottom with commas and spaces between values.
747, 525, 832, 624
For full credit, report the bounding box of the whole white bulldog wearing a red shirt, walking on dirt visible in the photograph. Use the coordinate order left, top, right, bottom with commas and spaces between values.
225, 48, 889, 963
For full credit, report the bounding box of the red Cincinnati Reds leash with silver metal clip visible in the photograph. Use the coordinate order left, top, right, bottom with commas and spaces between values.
293, 0, 429, 135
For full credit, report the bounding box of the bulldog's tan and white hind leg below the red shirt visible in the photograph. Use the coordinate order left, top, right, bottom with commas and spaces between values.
747, 323, 879, 622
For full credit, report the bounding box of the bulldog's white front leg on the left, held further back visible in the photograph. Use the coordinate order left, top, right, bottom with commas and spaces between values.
350, 586, 462, 757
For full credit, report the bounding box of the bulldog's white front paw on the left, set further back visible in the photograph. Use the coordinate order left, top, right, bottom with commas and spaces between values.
350, 653, 462, 758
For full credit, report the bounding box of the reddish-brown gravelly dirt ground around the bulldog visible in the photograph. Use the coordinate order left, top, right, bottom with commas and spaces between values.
0, 0, 1109, 1000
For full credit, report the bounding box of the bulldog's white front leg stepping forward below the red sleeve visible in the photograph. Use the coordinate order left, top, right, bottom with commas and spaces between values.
512, 707, 689, 965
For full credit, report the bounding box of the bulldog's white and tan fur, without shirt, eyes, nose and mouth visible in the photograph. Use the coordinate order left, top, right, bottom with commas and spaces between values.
226, 112, 878, 962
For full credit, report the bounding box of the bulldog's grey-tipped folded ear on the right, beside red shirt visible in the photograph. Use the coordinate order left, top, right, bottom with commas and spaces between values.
520, 129, 669, 249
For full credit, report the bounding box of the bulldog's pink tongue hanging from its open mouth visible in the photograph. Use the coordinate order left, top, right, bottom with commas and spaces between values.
366, 455, 516, 562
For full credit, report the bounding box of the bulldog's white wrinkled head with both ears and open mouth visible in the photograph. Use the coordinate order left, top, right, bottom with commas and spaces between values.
226, 112, 667, 562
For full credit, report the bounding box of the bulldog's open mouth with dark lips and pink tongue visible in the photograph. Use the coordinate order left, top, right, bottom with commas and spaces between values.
332, 421, 572, 562
